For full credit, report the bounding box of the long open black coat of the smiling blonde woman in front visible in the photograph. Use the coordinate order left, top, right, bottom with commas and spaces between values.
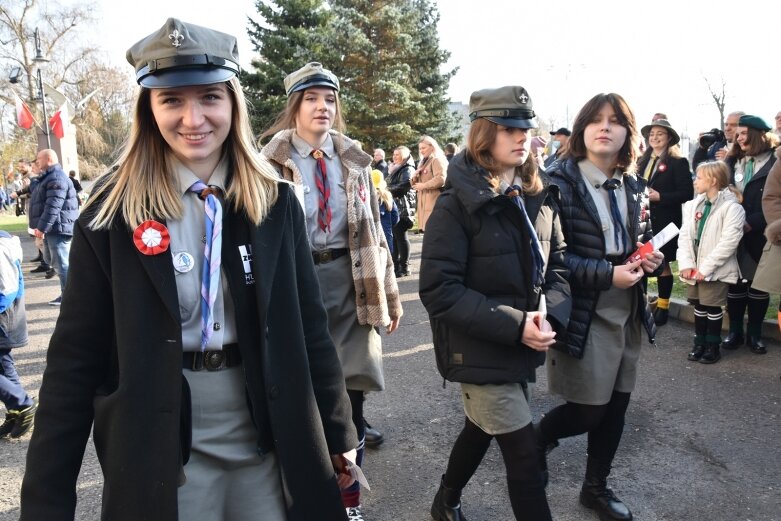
21, 184, 357, 521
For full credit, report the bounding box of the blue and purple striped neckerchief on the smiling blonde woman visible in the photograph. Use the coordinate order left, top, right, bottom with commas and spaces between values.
189, 181, 222, 351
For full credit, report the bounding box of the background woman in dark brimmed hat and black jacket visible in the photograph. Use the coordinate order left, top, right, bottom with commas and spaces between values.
637, 119, 694, 326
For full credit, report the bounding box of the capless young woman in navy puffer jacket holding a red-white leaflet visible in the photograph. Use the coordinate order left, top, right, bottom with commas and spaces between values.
538, 93, 664, 520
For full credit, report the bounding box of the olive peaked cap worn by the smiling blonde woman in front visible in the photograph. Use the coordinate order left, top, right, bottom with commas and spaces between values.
127, 18, 239, 89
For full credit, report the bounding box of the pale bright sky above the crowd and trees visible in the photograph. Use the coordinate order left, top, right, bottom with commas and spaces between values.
76, 0, 781, 140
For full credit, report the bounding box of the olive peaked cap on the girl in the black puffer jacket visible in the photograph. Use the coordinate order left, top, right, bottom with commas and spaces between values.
469, 85, 537, 128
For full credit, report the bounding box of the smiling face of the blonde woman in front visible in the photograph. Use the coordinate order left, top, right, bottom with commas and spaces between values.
150, 83, 233, 179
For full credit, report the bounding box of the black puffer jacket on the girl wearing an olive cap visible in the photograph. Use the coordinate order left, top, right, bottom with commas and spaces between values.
420, 151, 570, 384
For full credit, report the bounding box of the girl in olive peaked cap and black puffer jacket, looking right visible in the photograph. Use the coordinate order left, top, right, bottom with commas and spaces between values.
420, 86, 570, 521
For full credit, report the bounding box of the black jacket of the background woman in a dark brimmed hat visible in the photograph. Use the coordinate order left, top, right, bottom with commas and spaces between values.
637, 156, 694, 262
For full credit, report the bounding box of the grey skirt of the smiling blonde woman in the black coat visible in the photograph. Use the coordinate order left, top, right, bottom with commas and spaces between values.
178, 366, 287, 521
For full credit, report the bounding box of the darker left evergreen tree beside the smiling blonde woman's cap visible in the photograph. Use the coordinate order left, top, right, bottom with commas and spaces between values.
241, 0, 332, 135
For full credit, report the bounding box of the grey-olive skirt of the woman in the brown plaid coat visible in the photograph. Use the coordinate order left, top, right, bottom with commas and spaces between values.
315, 254, 385, 391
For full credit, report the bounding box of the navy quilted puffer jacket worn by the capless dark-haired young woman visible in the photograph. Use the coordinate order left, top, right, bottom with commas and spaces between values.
548, 158, 661, 358
